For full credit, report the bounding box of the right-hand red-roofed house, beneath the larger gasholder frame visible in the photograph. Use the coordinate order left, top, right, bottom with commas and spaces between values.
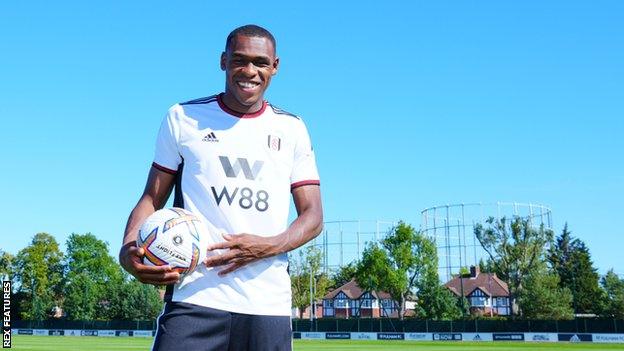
444, 266, 511, 316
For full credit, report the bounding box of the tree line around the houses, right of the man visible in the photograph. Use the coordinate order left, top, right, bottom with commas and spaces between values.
290, 218, 624, 320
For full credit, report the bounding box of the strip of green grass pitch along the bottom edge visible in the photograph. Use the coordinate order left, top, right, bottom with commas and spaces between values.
8, 335, 624, 351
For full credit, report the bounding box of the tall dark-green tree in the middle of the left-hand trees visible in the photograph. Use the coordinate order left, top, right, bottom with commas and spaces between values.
64, 233, 124, 320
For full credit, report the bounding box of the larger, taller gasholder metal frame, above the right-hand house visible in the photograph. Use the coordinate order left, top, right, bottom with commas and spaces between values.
420, 202, 552, 281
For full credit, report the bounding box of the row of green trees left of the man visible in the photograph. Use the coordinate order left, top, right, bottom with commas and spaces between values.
0, 233, 162, 321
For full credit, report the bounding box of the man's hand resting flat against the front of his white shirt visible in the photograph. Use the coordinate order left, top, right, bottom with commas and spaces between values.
204, 234, 280, 275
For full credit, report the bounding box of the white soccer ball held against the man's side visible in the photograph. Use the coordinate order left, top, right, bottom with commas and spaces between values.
137, 207, 210, 277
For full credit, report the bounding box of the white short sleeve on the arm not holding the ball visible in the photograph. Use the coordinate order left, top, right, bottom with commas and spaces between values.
290, 122, 321, 190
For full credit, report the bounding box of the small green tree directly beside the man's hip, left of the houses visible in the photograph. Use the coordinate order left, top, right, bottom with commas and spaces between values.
289, 245, 331, 318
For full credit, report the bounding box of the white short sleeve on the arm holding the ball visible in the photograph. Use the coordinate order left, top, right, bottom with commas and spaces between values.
152, 107, 182, 174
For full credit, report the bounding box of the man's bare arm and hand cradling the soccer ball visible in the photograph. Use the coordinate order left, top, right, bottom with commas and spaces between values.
119, 167, 180, 285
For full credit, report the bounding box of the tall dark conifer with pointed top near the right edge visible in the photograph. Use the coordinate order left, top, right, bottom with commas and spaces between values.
548, 223, 604, 314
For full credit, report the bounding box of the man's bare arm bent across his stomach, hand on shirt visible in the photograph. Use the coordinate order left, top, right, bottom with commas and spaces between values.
204, 185, 323, 275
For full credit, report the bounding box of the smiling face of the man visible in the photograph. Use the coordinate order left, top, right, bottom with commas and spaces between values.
221, 35, 279, 112
